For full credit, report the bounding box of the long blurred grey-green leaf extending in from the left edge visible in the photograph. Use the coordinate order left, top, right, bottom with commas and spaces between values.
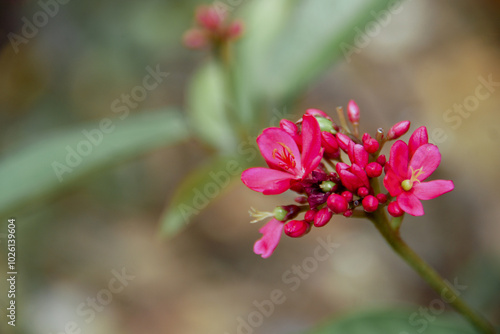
0, 110, 189, 216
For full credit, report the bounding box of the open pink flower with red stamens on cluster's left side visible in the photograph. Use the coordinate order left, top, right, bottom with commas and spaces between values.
241, 115, 323, 195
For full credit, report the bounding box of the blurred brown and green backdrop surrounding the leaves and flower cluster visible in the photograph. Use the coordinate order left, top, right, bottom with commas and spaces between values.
0, 0, 500, 334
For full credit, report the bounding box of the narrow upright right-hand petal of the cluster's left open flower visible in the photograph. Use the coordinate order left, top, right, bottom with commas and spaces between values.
302, 115, 322, 175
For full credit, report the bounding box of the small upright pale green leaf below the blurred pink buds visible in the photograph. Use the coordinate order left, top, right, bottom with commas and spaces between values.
188, 62, 240, 153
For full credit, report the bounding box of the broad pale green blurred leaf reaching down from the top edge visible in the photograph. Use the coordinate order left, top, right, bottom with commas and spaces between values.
242, 0, 394, 101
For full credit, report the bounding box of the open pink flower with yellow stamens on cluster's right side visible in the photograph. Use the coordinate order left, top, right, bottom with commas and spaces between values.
384, 138, 454, 216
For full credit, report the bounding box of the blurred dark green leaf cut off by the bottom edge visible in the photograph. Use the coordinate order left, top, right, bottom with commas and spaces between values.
304, 308, 476, 334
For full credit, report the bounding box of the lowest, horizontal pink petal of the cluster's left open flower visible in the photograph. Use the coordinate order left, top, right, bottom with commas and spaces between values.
241, 167, 294, 195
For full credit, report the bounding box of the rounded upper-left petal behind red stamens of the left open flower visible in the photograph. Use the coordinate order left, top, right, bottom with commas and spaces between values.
257, 128, 302, 175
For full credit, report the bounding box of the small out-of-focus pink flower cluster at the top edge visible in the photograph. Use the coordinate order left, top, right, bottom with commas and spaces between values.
183, 5, 243, 49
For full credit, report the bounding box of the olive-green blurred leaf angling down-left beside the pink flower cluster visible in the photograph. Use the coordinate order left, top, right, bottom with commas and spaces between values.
160, 156, 247, 237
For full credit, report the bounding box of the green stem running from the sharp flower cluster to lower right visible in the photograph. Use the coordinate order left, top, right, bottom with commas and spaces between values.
368, 208, 495, 334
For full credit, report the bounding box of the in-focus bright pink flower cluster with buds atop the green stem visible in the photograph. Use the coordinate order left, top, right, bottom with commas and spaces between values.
241, 100, 454, 258
